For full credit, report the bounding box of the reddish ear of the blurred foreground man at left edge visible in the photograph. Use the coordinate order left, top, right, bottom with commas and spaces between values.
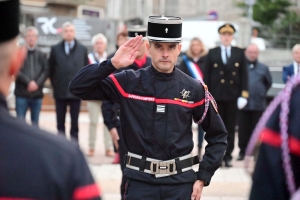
9, 47, 27, 76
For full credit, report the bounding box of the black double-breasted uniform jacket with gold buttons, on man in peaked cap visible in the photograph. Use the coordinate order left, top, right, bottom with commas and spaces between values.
204, 47, 248, 101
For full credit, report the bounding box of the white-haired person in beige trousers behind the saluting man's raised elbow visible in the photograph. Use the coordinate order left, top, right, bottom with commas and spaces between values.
87, 33, 114, 157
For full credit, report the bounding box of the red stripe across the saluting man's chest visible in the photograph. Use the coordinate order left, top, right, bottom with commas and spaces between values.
109, 74, 205, 108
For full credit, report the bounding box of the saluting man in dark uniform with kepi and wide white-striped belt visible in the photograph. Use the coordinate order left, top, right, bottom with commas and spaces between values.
69, 16, 227, 200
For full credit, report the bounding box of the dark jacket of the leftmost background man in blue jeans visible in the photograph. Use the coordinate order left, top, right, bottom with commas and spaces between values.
15, 49, 49, 98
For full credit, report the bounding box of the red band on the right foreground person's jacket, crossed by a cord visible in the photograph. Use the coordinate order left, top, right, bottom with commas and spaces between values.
260, 128, 300, 156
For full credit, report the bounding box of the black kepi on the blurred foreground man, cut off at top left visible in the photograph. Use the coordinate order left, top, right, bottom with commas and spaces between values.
0, 0, 20, 43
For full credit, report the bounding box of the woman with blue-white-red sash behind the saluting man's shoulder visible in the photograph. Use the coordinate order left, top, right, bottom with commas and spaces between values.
177, 37, 207, 159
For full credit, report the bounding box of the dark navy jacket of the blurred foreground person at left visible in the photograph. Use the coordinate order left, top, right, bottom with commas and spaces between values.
0, 94, 100, 200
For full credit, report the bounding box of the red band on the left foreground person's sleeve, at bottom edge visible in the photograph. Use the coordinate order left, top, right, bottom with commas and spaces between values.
72, 183, 100, 200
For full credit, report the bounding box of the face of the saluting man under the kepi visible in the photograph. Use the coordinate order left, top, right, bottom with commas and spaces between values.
147, 42, 181, 73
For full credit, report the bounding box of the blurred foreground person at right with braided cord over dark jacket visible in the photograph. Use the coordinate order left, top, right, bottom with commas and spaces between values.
246, 75, 300, 200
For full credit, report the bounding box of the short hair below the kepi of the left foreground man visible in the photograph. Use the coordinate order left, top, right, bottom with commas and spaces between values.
0, 37, 17, 75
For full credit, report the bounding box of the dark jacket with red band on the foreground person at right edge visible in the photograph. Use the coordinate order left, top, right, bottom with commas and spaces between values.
250, 85, 300, 200
